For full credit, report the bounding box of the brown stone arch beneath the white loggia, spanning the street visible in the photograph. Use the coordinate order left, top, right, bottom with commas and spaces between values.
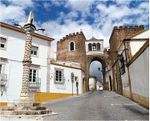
86, 55, 106, 90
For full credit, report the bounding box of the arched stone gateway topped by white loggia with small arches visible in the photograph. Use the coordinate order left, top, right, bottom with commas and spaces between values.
85, 37, 106, 89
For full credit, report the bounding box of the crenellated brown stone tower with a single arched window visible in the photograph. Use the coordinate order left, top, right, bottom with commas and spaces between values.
56, 32, 86, 72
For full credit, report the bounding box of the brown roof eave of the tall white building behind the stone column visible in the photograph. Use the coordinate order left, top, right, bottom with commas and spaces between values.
0, 22, 54, 41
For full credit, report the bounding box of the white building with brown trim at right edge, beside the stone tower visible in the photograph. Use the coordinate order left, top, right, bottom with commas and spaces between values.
118, 30, 149, 107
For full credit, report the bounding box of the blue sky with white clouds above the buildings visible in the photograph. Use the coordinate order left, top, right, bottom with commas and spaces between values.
0, 0, 149, 50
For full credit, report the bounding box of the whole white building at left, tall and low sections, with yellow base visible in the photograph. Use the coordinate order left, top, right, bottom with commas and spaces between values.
0, 23, 84, 105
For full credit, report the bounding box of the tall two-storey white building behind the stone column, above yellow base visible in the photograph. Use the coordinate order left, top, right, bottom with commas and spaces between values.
0, 23, 53, 103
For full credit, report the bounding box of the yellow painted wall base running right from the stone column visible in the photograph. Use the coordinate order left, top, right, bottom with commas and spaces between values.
35, 92, 76, 103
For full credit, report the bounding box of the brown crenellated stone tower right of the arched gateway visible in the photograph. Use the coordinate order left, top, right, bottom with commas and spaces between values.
109, 25, 144, 94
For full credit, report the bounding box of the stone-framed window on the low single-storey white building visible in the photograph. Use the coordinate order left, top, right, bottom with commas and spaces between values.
55, 68, 64, 83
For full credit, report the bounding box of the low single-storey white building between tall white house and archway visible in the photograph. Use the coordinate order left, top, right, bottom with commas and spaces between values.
49, 61, 84, 94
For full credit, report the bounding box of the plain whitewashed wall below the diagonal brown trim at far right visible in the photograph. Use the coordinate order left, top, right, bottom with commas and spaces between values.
129, 47, 149, 97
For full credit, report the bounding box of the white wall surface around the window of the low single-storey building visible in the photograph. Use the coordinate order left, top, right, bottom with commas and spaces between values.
50, 64, 83, 94
